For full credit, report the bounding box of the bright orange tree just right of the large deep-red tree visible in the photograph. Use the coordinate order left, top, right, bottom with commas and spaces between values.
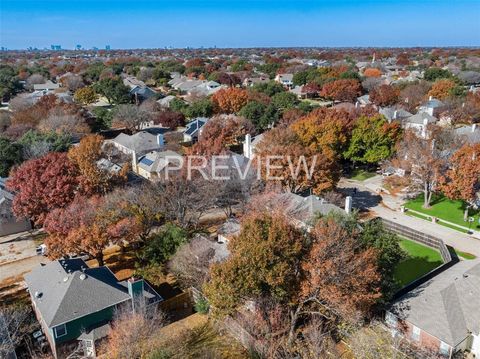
68, 135, 128, 195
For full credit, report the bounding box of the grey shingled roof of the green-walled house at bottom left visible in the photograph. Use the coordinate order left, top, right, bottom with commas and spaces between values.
25, 258, 131, 327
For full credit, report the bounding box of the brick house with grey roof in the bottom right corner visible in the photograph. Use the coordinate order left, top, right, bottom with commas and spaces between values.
385, 260, 480, 358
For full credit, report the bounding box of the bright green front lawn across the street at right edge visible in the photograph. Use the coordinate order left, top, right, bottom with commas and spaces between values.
405, 194, 480, 231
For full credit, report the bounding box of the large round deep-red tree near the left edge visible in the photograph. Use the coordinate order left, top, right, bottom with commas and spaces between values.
7, 152, 79, 225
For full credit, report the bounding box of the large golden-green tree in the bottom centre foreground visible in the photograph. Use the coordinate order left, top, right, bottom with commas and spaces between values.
204, 213, 304, 314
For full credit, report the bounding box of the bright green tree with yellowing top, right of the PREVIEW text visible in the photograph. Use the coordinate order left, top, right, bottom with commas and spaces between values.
344, 115, 401, 164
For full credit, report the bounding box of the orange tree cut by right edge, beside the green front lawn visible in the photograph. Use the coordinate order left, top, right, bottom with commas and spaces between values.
440, 143, 480, 220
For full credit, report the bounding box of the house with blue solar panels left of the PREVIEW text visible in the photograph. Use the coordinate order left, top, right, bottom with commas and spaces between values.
132, 151, 183, 181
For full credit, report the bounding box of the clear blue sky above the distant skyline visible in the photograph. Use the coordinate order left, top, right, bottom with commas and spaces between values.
0, 0, 480, 49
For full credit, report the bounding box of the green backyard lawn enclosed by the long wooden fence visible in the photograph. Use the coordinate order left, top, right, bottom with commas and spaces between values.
395, 239, 443, 286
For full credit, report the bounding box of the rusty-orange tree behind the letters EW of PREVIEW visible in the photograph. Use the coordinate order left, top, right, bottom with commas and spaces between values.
255, 128, 340, 194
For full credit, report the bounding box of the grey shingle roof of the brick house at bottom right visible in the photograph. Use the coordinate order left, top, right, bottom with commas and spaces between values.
391, 260, 480, 347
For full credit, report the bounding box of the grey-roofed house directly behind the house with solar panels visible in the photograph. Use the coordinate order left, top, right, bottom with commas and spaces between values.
110, 131, 165, 156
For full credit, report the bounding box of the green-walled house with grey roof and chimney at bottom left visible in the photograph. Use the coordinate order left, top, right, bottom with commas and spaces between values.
25, 258, 163, 358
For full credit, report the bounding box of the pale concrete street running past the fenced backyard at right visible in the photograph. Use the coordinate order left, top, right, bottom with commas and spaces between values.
338, 176, 480, 257
